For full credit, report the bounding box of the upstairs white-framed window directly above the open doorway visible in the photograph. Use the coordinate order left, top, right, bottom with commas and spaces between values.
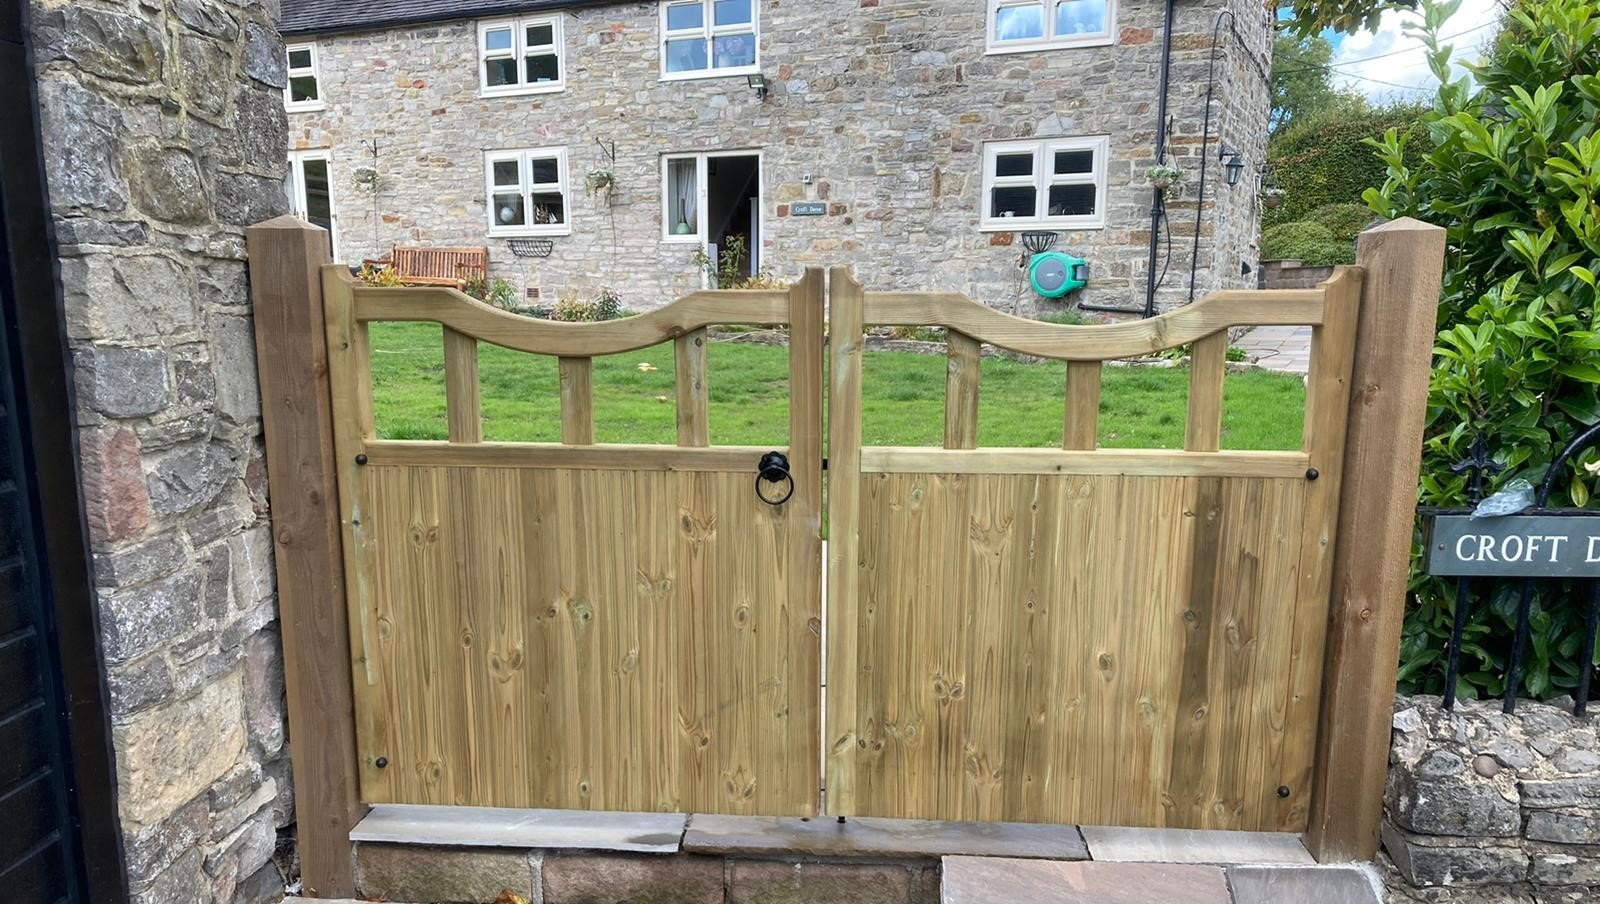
661, 0, 760, 78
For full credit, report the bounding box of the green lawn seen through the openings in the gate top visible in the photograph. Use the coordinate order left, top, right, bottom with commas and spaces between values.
371, 323, 1306, 450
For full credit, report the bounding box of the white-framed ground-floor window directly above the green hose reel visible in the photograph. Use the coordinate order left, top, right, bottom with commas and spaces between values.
982, 134, 1110, 232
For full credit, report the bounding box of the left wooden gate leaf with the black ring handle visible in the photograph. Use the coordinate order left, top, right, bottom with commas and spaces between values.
323, 266, 822, 814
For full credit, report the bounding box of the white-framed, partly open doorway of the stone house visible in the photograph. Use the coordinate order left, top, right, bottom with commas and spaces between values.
662, 150, 762, 277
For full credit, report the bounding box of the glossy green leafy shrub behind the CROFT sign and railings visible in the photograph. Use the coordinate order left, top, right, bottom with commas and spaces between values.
1365, 0, 1600, 698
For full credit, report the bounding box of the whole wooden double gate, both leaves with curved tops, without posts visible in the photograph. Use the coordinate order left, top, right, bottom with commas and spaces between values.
323, 267, 1362, 830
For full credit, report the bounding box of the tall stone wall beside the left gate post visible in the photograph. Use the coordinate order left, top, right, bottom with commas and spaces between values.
32, 0, 293, 904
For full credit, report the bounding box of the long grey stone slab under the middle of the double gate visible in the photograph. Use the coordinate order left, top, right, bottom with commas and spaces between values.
683, 813, 1090, 861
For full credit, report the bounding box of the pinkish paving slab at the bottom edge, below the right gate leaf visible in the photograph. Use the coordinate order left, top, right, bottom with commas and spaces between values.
939, 858, 1228, 904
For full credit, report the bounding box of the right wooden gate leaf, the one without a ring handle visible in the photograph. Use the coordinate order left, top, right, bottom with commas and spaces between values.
826, 269, 1362, 830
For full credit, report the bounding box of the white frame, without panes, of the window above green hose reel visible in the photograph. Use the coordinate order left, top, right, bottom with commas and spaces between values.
978, 134, 1110, 232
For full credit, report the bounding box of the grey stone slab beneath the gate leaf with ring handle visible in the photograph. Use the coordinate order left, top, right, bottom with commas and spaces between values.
350, 803, 688, 854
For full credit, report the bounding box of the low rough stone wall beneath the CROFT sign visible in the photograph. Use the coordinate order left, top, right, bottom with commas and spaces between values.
1382, 698, 1600, 904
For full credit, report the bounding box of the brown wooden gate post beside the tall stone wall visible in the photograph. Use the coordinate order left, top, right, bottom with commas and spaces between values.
245, 216, 365, 898
